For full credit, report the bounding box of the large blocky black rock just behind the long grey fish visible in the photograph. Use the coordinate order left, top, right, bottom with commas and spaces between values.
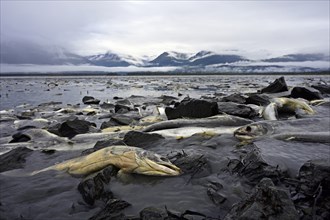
165, 99, 218, 120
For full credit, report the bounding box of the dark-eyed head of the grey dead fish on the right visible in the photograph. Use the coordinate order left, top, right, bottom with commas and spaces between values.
234, 124, 267, 141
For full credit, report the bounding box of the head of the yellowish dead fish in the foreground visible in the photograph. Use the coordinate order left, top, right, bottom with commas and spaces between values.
133, 150, 181, 176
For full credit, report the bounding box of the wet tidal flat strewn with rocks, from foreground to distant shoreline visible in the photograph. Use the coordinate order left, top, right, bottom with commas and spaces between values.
0, 75, 330, 220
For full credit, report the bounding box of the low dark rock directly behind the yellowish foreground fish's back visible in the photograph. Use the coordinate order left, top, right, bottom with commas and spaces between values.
124, 131, 165, 149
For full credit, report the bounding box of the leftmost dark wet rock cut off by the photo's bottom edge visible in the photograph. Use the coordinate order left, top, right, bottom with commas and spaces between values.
89, 199, 131, 220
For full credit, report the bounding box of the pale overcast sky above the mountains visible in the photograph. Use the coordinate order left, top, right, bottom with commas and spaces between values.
1, 0, 330, 56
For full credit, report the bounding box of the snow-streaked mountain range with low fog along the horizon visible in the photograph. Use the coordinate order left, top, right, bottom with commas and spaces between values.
0, 42, 330, 72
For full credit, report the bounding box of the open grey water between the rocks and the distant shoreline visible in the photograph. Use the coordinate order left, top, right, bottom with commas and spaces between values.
0, 75, 330, 110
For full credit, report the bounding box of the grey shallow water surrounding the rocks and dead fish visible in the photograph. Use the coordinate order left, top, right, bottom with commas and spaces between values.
0, 76, 330, 220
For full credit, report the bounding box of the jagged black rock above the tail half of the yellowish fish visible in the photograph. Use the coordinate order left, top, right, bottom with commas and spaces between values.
55, 119, 96, 138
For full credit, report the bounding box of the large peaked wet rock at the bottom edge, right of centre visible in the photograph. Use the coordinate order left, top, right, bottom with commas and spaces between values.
225, 178, 299, 220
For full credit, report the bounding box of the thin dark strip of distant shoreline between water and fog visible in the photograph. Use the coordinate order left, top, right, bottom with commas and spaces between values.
0, 71, 330, 77
